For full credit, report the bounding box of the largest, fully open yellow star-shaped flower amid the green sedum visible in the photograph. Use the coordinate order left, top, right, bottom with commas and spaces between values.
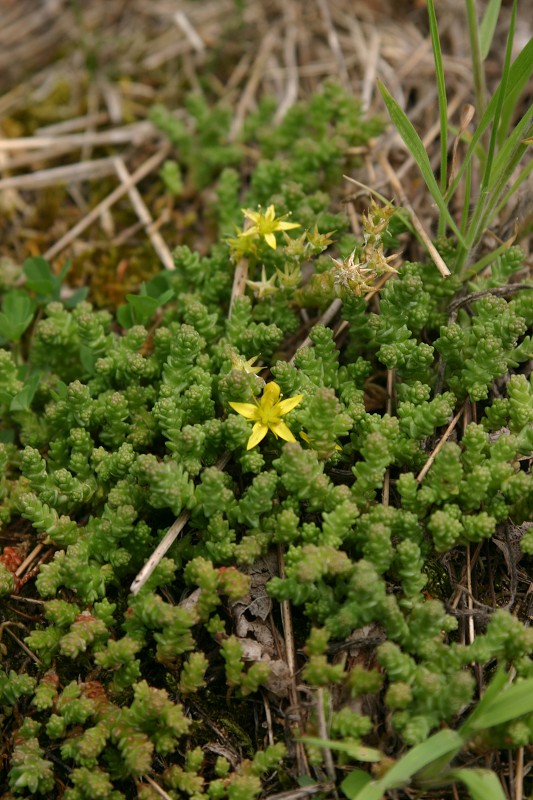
230, 381, 303, 450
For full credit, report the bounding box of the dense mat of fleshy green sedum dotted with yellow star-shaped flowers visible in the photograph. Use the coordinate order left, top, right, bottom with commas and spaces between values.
0, 23, 533, 800
